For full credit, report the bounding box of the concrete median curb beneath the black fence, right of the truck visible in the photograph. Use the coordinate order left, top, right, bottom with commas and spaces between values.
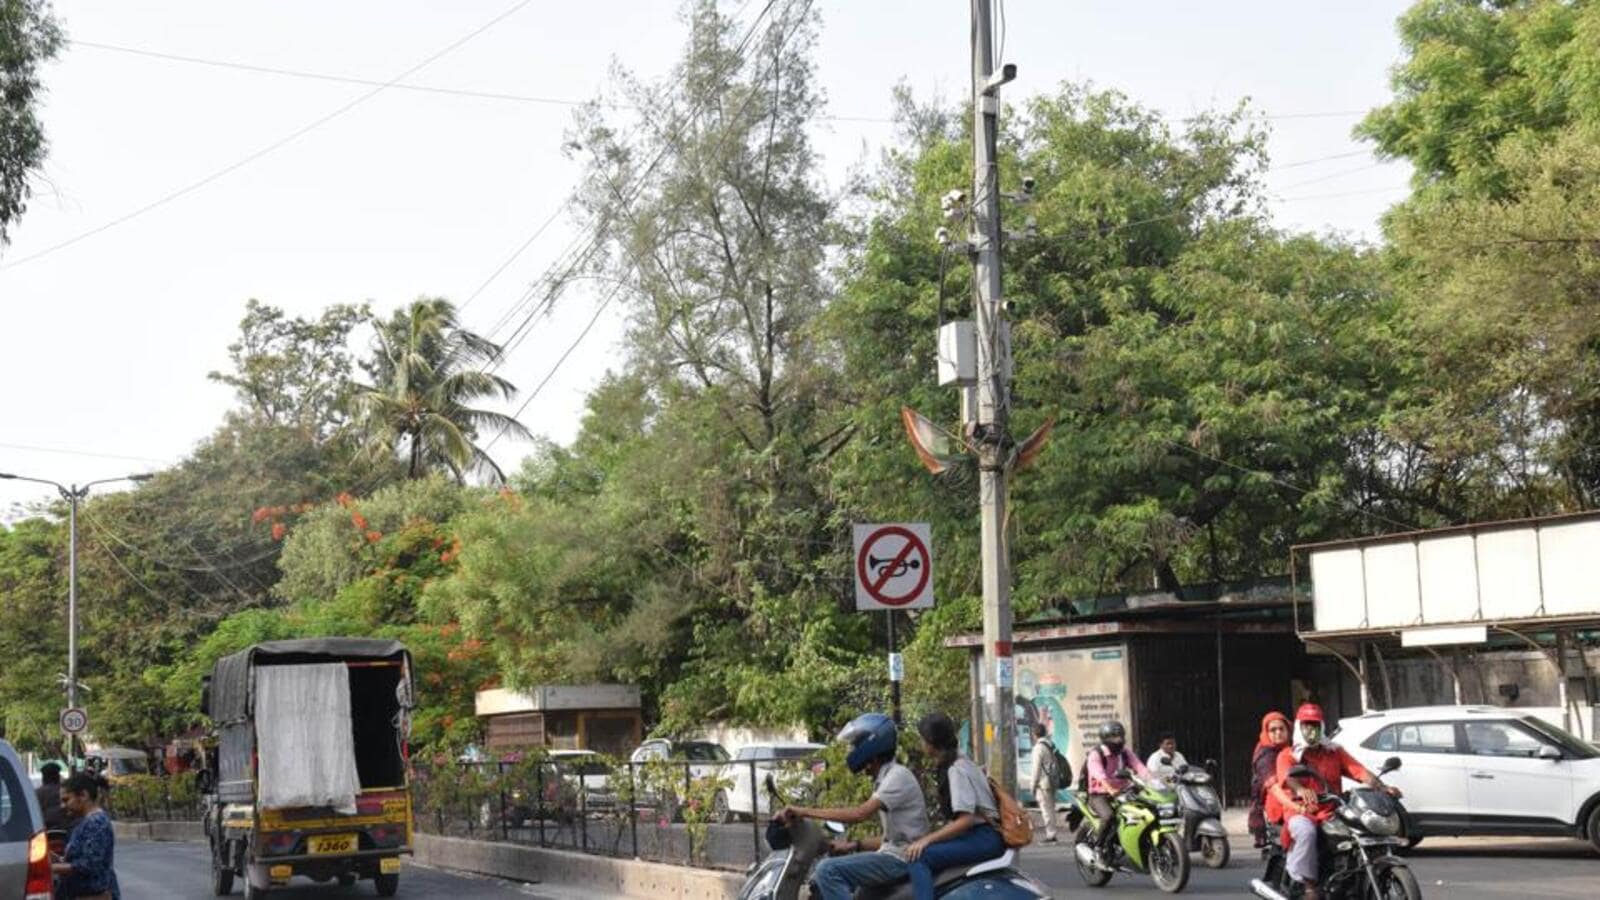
411, 833, 744, 900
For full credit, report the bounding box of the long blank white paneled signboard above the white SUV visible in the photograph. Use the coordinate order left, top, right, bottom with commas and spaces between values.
1310, 516, 1600, 642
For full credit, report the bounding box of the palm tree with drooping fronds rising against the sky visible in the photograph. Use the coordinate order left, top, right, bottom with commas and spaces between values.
352, 298, 533, 480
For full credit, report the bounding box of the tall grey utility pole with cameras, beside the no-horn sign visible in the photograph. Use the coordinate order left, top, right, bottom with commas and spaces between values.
970, 0, 1016, 794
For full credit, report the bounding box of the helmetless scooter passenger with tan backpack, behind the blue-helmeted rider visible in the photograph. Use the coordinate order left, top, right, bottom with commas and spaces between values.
906, 713, 1005, 900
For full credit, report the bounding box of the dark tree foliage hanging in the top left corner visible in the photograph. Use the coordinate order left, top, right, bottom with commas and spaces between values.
0, 0, 62, 248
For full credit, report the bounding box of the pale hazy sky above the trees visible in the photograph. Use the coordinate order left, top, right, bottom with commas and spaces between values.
0, 0, 1410, 520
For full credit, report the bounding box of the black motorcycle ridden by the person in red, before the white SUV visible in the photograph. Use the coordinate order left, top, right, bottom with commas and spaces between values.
1250, 756, 1422, 900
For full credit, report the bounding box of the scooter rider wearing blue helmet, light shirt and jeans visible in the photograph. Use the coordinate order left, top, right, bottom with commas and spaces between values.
778, 713, 928, 900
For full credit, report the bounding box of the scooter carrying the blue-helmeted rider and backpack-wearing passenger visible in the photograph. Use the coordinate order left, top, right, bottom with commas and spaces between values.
739, 775, 1050, 900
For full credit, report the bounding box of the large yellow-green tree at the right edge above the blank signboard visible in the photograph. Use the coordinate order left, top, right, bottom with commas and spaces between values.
1358, 0, 1600, 520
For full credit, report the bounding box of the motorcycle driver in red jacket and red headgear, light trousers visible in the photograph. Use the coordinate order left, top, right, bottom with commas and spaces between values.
1272, 703, 1400, 900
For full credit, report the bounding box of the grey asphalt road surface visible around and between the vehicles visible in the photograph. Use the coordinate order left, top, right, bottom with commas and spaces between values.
117, 839, 1600, 900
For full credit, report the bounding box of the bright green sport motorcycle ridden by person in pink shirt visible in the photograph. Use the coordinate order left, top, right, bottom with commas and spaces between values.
1069, 770, 1189, 894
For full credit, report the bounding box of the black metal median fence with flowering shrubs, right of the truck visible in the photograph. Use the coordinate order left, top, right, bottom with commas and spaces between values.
413, 757, 819, 871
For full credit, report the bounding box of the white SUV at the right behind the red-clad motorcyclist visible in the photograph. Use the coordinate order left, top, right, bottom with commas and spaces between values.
1334, 706, 1600, 849
